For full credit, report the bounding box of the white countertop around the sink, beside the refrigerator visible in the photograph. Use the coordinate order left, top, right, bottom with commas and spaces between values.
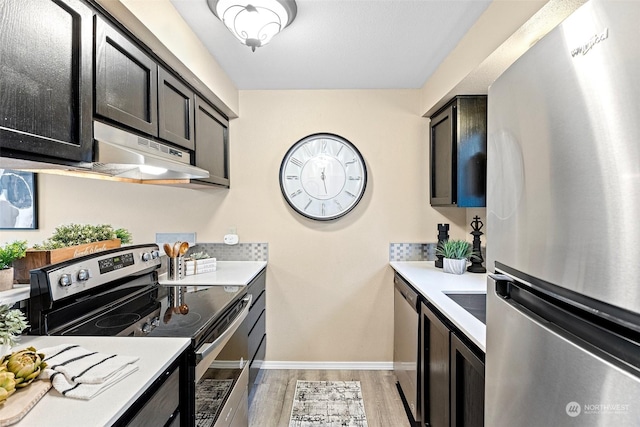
390, 261, 487, 351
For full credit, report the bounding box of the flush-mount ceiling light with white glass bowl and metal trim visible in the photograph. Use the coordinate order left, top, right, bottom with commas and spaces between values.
207, 0, 298, 52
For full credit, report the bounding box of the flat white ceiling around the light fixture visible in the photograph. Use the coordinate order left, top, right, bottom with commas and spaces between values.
171, 0, 491, 90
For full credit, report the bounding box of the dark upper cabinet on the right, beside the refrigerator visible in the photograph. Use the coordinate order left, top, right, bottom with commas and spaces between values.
429, 95, 487, 208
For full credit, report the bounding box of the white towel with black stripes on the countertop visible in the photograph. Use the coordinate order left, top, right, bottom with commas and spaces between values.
38, 344, 140, 400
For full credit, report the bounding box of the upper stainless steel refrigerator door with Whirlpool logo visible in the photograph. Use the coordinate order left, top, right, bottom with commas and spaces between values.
487, 0, 640, 312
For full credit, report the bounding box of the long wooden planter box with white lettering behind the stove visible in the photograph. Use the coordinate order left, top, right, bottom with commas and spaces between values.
13, 239, 120, 283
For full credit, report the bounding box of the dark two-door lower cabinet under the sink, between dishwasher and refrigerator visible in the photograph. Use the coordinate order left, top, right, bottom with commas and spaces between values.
420, 303, 484, 427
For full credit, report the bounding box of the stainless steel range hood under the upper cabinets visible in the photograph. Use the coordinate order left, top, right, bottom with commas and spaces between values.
91, 121, 209, 180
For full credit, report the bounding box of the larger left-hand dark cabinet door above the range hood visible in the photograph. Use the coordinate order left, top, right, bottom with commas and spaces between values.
96, 18, 158, 136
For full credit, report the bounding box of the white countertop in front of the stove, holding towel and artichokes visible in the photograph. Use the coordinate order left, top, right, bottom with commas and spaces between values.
9, 336, 190, 427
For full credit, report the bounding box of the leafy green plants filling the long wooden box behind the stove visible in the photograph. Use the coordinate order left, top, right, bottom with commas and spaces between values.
33, 224, 132, 250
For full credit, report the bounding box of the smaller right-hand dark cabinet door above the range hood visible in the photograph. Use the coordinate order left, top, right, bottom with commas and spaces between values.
158, 67, 195, 150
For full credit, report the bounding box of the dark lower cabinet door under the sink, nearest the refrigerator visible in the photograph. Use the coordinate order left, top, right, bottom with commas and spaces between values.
451, 334, 484, 427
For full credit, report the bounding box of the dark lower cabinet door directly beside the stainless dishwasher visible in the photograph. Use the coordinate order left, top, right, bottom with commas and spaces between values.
421, 304, 450, 427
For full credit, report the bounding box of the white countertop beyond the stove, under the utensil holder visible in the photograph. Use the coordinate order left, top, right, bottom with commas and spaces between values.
158, 261, 267, 286
